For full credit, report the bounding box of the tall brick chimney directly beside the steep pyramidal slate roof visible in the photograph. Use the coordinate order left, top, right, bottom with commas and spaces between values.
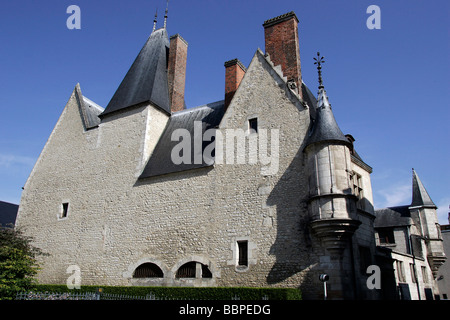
168, 34, 188, 112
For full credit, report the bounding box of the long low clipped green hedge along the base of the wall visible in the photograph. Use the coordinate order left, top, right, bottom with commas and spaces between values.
36, 285, 302, 300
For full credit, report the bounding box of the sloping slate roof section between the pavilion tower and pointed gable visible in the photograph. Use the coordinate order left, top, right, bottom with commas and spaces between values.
140, 100, 225, 178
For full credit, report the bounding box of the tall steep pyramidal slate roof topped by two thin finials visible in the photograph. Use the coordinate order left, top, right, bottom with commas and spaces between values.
101, 28, 170, 117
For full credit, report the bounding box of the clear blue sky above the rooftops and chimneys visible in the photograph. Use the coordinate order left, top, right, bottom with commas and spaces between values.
0, 0, 450, 223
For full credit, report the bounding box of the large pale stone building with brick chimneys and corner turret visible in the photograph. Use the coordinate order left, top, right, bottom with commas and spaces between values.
16, 12, 444, 299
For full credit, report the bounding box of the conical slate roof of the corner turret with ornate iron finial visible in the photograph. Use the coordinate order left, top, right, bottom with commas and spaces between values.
305, 88, 350, 146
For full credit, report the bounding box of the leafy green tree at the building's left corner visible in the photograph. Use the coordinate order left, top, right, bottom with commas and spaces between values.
0, 225, 44, 300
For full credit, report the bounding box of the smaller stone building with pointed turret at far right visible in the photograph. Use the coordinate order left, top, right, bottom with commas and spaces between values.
374, 169, 446, 300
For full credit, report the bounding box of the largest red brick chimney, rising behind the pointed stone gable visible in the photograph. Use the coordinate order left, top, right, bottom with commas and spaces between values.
263, 11, 302, 96
